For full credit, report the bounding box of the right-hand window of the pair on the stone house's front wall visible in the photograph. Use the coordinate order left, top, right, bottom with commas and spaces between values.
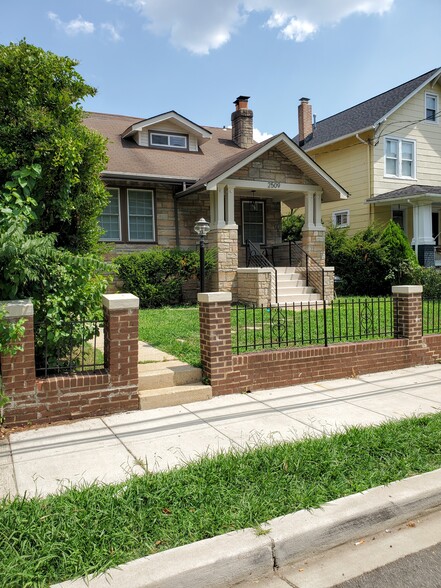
127, 190, 155, 241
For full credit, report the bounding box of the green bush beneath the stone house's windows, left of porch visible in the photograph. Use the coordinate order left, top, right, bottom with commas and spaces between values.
115, 248, 214, 308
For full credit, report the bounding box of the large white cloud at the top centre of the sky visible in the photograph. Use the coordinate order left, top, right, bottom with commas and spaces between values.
108, 0, 394, 55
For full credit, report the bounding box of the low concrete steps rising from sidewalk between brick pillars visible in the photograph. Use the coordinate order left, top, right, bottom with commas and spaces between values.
138, 360, 212, 410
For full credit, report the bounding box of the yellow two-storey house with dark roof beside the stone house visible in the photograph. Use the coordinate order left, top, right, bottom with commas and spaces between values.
294, 68, 441, 266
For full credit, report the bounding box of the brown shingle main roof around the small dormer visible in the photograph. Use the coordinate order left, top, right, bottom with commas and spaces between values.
84, 112, 244, 181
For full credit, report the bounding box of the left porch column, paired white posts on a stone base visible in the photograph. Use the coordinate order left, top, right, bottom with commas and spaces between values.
208, 185, 238, 300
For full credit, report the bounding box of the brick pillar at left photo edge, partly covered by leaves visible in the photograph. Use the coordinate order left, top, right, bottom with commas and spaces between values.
0, 300, 35, 408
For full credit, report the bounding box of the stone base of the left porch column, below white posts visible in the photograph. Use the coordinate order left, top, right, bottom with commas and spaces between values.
208, 227, 239, 300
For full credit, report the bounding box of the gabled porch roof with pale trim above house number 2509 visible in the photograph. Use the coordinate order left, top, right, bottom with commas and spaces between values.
177, 133, 349, 202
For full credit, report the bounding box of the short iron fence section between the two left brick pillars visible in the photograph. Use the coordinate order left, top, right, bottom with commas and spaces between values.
35, 320, 104, 376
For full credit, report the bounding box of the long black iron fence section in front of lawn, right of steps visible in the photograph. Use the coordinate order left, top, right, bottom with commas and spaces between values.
231, 298, 394, 353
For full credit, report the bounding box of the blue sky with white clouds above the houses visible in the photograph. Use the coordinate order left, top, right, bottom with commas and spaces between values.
0, 0, 441, 140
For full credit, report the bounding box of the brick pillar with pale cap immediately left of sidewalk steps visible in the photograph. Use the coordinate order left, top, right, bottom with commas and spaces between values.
103, 294, 139, 388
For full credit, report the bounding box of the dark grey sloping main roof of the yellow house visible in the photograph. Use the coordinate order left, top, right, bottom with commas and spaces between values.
294, 68, 441, 151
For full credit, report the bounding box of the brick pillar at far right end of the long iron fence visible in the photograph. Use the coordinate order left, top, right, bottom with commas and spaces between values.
392, 286, 423, 345
